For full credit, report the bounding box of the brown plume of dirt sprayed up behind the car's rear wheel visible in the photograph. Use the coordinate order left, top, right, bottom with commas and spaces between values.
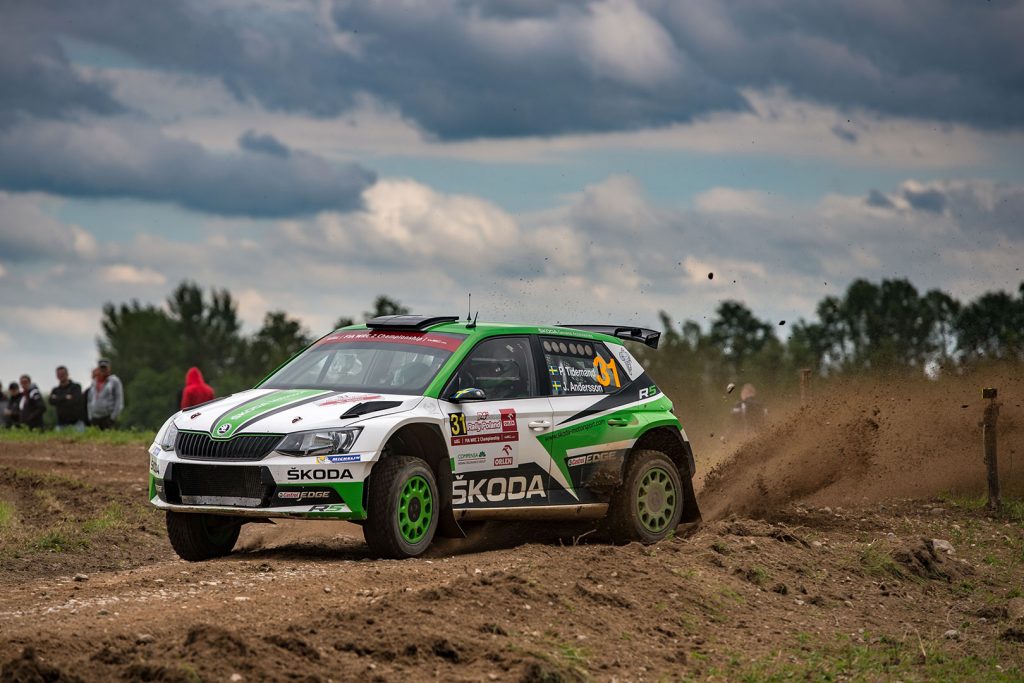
698, 371, 1024, 519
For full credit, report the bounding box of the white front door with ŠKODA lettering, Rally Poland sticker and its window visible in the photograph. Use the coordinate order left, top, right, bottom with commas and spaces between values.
440, 335, 552, 511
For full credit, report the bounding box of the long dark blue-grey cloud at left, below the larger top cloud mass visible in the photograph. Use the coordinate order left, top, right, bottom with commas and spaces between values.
0, 122, 375, 217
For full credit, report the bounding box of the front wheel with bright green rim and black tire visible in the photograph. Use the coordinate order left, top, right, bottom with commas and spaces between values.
362, 456, 441, 559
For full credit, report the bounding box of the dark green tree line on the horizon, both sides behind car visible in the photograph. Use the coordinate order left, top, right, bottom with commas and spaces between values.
98, 280, 1024, 428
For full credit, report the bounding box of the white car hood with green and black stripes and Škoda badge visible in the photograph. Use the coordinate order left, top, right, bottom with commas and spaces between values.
174, 389, 423, 438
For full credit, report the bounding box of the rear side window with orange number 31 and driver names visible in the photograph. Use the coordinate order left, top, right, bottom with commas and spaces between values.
541, 337, 618, 396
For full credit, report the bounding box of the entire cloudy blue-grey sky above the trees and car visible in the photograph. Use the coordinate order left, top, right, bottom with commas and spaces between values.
0, 0, 1024, 387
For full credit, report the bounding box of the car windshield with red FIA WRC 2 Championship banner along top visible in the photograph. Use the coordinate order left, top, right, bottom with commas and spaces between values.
260, 330, 465, 394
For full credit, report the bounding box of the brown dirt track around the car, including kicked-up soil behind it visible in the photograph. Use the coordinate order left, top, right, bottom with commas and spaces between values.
0, 370, 1024, 681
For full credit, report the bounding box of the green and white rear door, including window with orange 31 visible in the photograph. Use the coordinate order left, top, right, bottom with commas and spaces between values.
539, 337, 640, 504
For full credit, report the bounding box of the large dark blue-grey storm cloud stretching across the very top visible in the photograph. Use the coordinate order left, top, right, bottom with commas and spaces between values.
0, 0, 1024, 141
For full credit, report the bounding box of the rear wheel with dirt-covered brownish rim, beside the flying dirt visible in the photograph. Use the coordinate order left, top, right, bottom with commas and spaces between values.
605, 451, 686, 545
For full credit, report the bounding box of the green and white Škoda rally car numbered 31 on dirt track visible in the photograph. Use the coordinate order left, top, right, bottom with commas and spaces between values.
150, 315, 699, 560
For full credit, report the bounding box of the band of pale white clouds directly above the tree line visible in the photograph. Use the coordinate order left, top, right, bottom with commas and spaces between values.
0, 176, 1024, 393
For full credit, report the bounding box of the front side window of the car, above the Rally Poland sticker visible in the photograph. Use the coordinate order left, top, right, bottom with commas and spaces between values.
443, 337, 537, 400
